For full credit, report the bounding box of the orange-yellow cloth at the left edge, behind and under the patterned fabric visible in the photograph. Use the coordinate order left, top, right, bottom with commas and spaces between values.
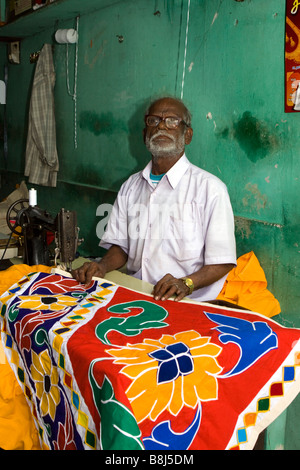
0, 264, 51, 450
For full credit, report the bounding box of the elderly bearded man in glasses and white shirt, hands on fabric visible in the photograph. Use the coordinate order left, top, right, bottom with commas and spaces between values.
73, 98, 236, 301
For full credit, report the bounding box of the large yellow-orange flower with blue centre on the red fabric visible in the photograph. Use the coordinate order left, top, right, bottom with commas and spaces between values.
107, 331, 222, 422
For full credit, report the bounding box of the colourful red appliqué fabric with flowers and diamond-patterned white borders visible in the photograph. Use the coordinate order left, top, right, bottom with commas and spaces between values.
0, 273, 300, 450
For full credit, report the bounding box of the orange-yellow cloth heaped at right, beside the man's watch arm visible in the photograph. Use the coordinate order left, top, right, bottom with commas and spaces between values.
218, 251, 281, 317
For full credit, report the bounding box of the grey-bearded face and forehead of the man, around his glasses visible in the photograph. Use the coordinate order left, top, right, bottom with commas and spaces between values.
144, 98, 192, 158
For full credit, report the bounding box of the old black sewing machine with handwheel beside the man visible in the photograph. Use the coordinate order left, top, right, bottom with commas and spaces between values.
6, 199, 82, 271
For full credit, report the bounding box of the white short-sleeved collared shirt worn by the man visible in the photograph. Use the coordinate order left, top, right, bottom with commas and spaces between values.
100, 154, 236, 301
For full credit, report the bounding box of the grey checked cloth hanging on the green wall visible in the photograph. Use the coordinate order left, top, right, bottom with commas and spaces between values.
25, 44, 59, 187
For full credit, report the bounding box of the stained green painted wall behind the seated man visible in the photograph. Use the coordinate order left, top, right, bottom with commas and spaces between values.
0, 0, 300, 448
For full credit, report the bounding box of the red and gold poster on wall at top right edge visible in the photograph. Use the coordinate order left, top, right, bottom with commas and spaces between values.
285, 0, 300, 113
